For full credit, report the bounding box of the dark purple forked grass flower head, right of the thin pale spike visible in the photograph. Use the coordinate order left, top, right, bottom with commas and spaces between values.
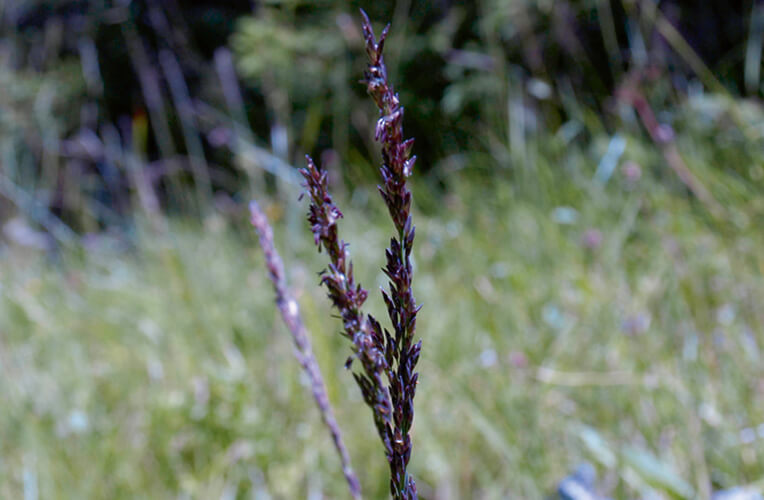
301, 11, 421, 500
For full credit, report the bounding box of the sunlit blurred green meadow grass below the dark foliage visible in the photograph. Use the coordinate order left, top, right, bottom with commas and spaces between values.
0, 123, 764, 499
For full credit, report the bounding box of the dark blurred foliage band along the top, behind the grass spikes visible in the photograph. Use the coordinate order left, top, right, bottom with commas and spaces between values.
0, 0, 764, 232
